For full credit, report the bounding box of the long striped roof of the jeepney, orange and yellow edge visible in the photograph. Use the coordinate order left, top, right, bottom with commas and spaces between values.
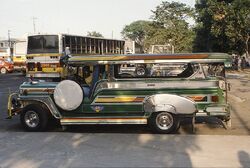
68, 53, 231, 64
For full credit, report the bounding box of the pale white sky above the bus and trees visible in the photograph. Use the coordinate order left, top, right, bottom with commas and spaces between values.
0, 0, 195, 39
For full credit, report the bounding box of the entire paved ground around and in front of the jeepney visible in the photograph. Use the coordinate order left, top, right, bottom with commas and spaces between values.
0, 73, 250, 168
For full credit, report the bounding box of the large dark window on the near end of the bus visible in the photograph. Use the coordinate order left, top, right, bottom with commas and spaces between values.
27, 35, 59, 54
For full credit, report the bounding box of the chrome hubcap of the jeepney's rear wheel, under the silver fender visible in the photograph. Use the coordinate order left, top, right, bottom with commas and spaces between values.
156, 112, 174, 130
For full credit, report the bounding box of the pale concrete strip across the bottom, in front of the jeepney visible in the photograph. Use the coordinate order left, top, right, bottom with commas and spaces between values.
0, 132, 250, 168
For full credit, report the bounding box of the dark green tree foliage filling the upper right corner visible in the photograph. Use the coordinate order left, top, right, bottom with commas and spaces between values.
193, 0, 250, 54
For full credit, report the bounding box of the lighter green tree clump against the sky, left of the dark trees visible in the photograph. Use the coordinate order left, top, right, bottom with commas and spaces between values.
122, 2, 194, 52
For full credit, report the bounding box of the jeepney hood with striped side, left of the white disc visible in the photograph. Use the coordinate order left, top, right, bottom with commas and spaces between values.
19, 82, 58, 95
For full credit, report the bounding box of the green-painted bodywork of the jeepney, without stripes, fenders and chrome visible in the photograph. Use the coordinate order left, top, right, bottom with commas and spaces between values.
20, 81, 225, 117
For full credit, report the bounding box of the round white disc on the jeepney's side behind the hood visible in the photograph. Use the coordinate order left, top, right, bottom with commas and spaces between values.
54, 80, 83, 111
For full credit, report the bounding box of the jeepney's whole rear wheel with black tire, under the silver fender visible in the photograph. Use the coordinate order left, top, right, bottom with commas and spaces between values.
149, 112, 180, 134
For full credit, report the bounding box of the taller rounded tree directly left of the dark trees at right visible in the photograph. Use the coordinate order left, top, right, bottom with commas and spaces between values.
151, 1, 194, 52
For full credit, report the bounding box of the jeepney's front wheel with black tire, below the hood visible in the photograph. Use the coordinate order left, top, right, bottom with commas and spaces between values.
20, 104, 48, 132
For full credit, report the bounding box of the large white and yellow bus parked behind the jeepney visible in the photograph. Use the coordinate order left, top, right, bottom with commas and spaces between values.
26, 34, 125, 79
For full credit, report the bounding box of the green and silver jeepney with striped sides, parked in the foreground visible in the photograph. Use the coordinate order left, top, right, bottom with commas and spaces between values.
8, 53, 231, 133
